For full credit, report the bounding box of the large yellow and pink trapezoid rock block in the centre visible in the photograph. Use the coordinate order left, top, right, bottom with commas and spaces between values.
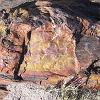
21, 22, 78, 83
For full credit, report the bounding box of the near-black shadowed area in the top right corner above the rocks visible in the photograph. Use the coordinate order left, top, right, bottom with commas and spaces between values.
52, 0, 100, 20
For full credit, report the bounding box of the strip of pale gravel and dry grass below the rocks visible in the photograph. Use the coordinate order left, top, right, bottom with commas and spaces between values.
3, 83, 100, 100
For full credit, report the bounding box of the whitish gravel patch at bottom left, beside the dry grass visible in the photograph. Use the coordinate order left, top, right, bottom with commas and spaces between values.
3, 83, 56, 100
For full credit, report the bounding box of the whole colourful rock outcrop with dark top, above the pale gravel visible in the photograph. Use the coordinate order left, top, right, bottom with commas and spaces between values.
0, 0, 100, 94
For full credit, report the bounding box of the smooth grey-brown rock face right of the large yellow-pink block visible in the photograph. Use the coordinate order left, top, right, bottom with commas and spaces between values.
76, 36, 100, 69
